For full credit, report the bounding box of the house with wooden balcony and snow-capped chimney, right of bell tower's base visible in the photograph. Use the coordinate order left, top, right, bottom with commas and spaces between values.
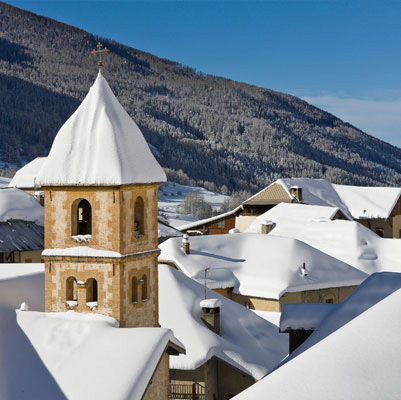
159, 265, 288, 400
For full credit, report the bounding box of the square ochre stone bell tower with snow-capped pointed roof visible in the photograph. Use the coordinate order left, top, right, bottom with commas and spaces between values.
37, 72, 166, 327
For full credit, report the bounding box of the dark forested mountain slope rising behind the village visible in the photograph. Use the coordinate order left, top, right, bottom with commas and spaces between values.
0, 3, 401, 191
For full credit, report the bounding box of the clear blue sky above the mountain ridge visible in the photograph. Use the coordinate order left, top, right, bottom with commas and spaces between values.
7, 0, 401, 146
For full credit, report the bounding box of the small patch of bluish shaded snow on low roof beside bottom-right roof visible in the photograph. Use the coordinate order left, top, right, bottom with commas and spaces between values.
280, 303, 337, 331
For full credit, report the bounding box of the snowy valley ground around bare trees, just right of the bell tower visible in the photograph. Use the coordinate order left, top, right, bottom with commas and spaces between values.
159, 182, 228, 227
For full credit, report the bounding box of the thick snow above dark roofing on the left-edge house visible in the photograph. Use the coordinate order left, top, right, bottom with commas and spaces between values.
0, 188, 44, 226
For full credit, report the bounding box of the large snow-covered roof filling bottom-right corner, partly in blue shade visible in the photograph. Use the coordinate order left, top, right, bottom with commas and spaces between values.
235, 273, 401, 400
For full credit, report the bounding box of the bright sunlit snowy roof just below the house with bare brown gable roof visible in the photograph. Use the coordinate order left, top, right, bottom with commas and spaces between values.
246, 203, 346, 237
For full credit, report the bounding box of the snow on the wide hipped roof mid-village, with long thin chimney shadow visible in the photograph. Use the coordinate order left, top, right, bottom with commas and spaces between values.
159, 233, 368, 299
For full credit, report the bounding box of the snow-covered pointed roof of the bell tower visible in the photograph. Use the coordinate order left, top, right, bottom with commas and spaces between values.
37, 72, 166, 186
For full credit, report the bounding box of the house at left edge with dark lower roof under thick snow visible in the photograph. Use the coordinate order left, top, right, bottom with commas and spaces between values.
0, 188, 44, 263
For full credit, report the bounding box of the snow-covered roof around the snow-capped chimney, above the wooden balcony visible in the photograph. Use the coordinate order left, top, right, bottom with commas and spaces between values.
159, 265, 288, 379
